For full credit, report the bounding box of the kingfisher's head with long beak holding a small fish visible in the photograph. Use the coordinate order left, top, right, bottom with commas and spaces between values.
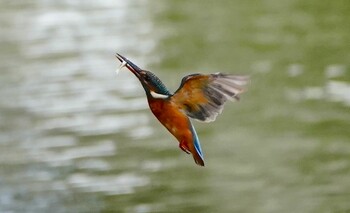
116, 53, 171, 99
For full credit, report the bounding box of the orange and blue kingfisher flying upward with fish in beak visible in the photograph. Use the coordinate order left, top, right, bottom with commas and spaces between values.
116, 53, 249, 166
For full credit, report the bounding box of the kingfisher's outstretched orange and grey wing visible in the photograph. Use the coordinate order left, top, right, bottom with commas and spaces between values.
171, 73, 249, 122
